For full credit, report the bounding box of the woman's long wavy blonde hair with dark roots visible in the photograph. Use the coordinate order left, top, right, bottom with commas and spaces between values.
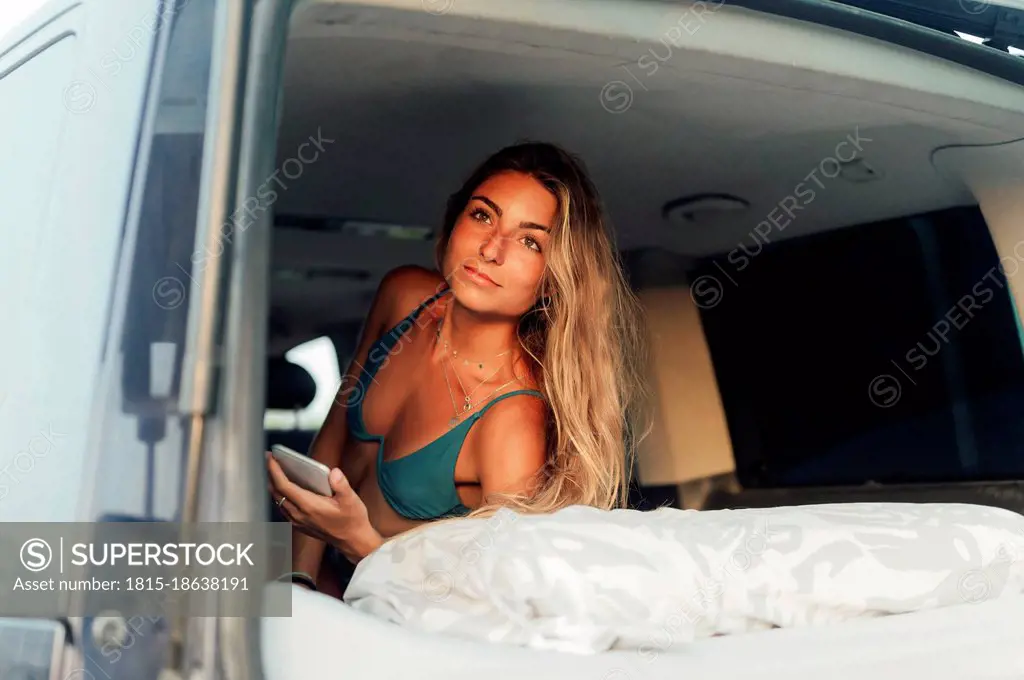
428, 142, 650, 523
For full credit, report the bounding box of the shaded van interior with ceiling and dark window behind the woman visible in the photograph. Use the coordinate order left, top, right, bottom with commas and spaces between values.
266, 0, 1024, 510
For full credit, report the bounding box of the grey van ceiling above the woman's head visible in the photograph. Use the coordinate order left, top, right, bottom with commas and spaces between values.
272, 0, 1024, 348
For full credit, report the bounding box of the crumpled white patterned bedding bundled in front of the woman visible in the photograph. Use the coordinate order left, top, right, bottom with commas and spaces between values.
345, 503, 1024, 654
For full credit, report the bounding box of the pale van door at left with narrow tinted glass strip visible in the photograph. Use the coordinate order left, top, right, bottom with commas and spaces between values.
0, 0, 258, 680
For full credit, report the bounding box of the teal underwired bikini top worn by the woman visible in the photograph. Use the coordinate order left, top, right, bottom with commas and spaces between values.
346, 289, 544, 519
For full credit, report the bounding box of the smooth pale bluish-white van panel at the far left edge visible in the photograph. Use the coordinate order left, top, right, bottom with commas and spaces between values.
0, 0, 174, 521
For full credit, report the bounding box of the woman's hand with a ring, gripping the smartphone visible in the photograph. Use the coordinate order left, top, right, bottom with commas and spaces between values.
266, 453, 383, 563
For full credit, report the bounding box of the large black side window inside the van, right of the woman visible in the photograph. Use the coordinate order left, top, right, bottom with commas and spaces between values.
690, 207, 1024, 487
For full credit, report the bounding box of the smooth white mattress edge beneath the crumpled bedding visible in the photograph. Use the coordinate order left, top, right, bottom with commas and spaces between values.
261, 585, 1024, 680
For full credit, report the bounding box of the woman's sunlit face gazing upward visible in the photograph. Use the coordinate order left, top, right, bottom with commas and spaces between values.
442, 171, 558, 316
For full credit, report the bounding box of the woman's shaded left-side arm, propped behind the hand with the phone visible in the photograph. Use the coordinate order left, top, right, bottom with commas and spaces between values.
292, 267, 431, 581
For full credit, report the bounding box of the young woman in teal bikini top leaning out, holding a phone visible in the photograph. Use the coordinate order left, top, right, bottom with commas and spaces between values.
267, 143, 646, 595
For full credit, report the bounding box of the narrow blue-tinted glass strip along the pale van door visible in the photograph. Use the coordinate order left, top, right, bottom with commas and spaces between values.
82, 2, 217, 520
